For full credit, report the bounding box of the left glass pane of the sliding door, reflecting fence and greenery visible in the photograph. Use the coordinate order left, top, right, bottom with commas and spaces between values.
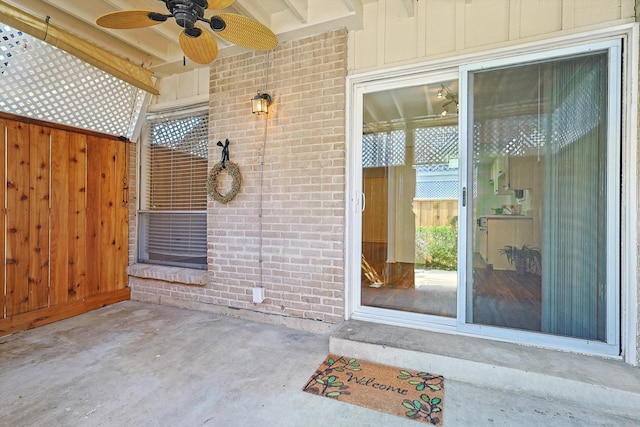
361, 80, 459, 318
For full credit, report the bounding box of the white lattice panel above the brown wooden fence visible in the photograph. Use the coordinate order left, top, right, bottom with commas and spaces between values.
0, 24, 145, 137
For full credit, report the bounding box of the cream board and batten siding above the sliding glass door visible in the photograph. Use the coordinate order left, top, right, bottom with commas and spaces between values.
349, 0, 635, 74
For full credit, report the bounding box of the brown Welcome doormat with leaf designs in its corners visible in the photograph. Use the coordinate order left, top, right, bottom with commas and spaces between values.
303, 354, 444, 425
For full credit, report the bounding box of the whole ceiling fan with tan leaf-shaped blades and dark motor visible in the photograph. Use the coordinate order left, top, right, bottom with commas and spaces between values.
96, 0, 278, 64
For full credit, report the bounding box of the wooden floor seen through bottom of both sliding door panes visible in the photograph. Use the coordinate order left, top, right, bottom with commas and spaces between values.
361, 266, 542, 331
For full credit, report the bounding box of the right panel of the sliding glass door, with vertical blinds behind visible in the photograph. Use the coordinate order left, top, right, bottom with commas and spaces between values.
464, 42, 620, 352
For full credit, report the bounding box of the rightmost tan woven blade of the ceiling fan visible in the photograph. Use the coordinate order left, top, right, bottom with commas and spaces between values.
213, 13, 278, 50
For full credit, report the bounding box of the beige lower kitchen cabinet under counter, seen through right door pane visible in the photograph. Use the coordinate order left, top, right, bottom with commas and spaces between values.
480, 215, 533, 270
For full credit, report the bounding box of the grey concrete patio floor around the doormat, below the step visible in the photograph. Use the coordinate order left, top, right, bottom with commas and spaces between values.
0, 301, 640, 427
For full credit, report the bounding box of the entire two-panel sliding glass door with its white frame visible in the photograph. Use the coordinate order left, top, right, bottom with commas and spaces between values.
351, 41, 621, 354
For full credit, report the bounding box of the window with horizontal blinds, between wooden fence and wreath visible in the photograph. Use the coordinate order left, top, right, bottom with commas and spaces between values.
138, 111, 208, 269
